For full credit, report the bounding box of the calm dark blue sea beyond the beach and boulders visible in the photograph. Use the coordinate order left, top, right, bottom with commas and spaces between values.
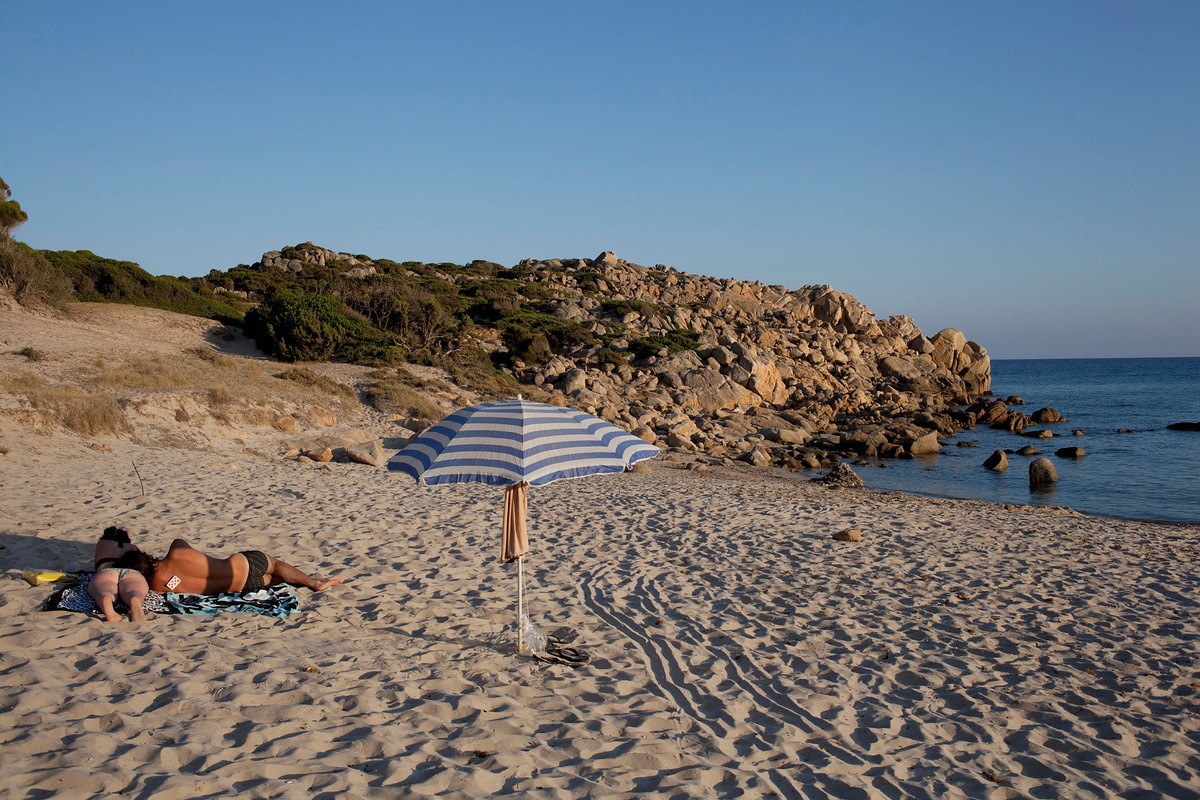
853, 359, 1200, 523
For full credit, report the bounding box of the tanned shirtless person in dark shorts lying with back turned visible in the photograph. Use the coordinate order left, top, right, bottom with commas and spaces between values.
150, 539, 342, 595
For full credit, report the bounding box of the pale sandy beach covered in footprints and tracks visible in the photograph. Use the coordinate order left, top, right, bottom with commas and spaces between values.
0, 306, 1200, 800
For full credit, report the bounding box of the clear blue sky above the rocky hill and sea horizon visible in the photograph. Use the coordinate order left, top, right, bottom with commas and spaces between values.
0, 1, 1200, 359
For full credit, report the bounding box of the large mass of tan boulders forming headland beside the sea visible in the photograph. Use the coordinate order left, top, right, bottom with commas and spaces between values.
512, 252, 993, 469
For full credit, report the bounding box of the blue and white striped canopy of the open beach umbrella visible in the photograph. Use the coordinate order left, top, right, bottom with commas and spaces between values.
388, 399, 659, 486
